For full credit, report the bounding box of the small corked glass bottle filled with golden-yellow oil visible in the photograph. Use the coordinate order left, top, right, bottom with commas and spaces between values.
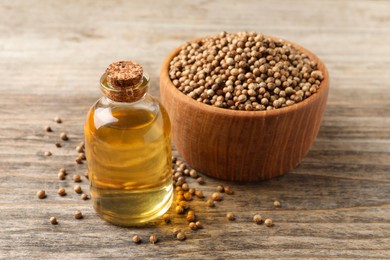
84, 61, 173, 226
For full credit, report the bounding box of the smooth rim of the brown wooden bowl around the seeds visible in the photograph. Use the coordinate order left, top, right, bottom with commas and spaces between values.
160, 35, 329, 118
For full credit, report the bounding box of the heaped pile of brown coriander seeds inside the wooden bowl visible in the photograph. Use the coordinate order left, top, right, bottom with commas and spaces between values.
169, 32, 323, 111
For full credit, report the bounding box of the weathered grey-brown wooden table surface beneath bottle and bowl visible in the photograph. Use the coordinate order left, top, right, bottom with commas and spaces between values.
0, 0, 390, 259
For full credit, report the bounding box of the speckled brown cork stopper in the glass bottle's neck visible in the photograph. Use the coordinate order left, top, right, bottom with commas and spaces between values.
106, 61, 143, 88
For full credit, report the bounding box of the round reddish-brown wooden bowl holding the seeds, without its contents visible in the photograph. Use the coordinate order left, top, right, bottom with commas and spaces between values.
160, 37, 329, 181
